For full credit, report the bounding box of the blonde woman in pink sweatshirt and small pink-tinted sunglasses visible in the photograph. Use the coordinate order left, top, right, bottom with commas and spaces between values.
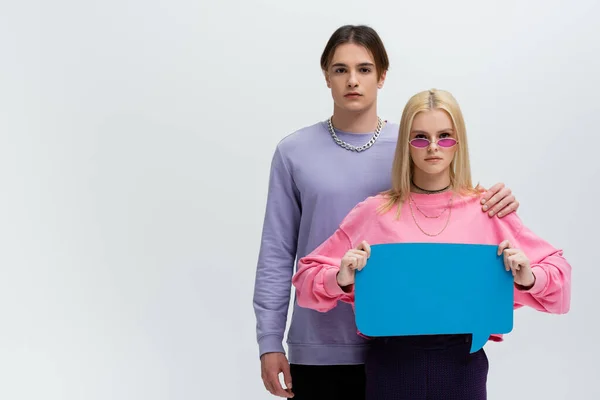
292, 90, 571, 400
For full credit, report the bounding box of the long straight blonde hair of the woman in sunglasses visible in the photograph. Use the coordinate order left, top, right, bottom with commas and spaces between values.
380, 89, 478, 216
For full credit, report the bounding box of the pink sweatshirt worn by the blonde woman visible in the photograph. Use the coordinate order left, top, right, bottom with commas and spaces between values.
292, 192, 571, 341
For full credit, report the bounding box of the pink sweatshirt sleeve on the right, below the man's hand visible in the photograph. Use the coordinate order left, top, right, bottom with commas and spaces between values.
505, 215, 571, 314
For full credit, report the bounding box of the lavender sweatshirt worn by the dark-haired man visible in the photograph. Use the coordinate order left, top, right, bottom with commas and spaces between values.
254, 121, 398, 365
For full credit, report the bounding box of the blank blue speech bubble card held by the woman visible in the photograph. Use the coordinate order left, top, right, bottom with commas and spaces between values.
355, 243, 514, 353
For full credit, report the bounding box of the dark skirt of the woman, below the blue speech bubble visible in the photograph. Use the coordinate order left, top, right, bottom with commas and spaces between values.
365, 335, 489, 400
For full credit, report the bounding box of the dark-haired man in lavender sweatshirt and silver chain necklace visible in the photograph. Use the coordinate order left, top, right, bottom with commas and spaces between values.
254, 25, 519, 400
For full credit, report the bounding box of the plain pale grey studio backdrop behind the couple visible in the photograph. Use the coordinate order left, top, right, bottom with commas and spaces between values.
0, 0, 600, 400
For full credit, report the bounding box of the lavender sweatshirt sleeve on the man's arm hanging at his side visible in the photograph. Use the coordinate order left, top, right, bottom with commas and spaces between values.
253, 147, 301, 356
